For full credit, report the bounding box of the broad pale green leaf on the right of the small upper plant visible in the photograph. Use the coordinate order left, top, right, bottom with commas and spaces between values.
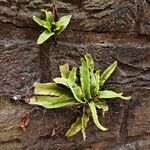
56, 15, 72, 34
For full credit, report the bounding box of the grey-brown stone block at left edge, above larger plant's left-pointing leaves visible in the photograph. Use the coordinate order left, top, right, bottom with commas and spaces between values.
0, 23, 39, 96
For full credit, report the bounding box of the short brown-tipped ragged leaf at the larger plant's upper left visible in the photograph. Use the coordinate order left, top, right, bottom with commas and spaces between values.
59, 63, 70, 78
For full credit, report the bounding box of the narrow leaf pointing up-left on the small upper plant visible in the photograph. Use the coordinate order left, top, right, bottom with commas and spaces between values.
33, 16, 52, 31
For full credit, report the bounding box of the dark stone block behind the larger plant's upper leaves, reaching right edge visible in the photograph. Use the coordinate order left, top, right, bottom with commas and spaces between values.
51, 30, 150, 90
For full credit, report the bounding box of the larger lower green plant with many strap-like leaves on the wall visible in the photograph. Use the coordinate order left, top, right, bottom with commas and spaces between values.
29, 54, 131, 139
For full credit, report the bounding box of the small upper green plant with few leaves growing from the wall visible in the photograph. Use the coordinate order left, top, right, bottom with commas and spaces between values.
33, 9, 72, 44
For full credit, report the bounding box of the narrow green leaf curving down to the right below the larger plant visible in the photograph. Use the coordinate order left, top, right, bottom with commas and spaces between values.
89, 101, 108, 131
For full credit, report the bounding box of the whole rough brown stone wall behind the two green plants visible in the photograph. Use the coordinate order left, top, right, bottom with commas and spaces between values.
0, 0, 150, 150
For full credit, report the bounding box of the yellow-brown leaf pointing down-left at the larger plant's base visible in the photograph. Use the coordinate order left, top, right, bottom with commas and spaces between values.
66, 117, 82, 137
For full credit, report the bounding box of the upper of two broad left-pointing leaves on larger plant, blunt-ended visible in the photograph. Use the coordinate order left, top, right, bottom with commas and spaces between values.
34, 83, 72, 97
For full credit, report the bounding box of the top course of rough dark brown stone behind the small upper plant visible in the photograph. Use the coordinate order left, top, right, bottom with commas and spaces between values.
0, 0, 150, 35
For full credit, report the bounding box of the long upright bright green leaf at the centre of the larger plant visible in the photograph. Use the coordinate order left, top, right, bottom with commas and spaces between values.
80, 58, 91, 100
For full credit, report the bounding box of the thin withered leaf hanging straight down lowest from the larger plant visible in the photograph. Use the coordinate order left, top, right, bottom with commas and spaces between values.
82, 106, 90, 140
